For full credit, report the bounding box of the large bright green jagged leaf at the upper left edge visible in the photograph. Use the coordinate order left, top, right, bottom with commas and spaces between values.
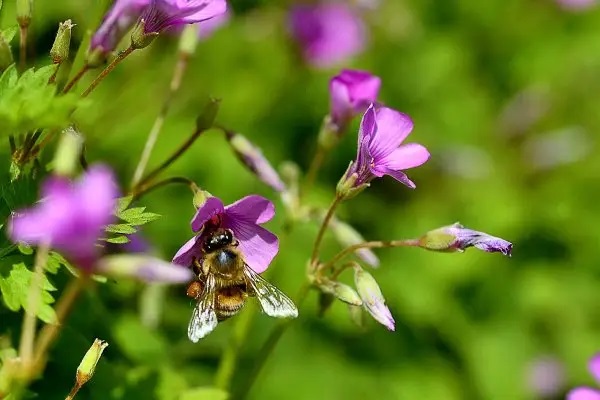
0, 65, 80, 136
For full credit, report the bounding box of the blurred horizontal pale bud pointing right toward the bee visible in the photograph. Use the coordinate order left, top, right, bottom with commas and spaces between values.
98, 254, 194, 284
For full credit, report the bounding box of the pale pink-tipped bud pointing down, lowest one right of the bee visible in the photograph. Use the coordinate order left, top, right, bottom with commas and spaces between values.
354, 266, 395, 331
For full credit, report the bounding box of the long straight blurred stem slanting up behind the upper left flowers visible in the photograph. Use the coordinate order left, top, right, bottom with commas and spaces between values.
131, 52, 190, 187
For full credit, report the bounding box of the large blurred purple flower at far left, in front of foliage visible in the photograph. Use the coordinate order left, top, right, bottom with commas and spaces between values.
9, 165, 118, 272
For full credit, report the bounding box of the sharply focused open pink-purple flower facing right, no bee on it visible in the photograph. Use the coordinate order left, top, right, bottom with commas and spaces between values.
346, 104, 429, 189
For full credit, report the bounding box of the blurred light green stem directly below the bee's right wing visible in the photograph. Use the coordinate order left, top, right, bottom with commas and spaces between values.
215, 307, 256, 390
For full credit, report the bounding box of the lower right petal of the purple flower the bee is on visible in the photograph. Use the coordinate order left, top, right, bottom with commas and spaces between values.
225, 218, 279, 274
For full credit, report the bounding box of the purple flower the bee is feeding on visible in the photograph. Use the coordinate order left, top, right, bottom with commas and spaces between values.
173, 195, 279, 273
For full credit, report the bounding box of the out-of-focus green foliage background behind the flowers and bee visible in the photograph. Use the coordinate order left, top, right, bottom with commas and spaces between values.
0, 0, 600, 400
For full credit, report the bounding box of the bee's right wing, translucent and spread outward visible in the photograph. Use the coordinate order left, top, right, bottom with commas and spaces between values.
244, 265, 298, 318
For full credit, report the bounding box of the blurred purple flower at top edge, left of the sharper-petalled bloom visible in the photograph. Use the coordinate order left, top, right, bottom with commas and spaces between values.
90, 0, 151, 54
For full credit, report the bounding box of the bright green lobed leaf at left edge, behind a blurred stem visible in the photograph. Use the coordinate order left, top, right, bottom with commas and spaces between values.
0, 263, 56, 323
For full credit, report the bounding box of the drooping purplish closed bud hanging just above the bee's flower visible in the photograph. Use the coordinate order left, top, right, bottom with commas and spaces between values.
226, 132, 285, 192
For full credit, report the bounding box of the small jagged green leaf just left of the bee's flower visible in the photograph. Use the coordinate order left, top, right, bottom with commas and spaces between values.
105, 196, 160, 244
